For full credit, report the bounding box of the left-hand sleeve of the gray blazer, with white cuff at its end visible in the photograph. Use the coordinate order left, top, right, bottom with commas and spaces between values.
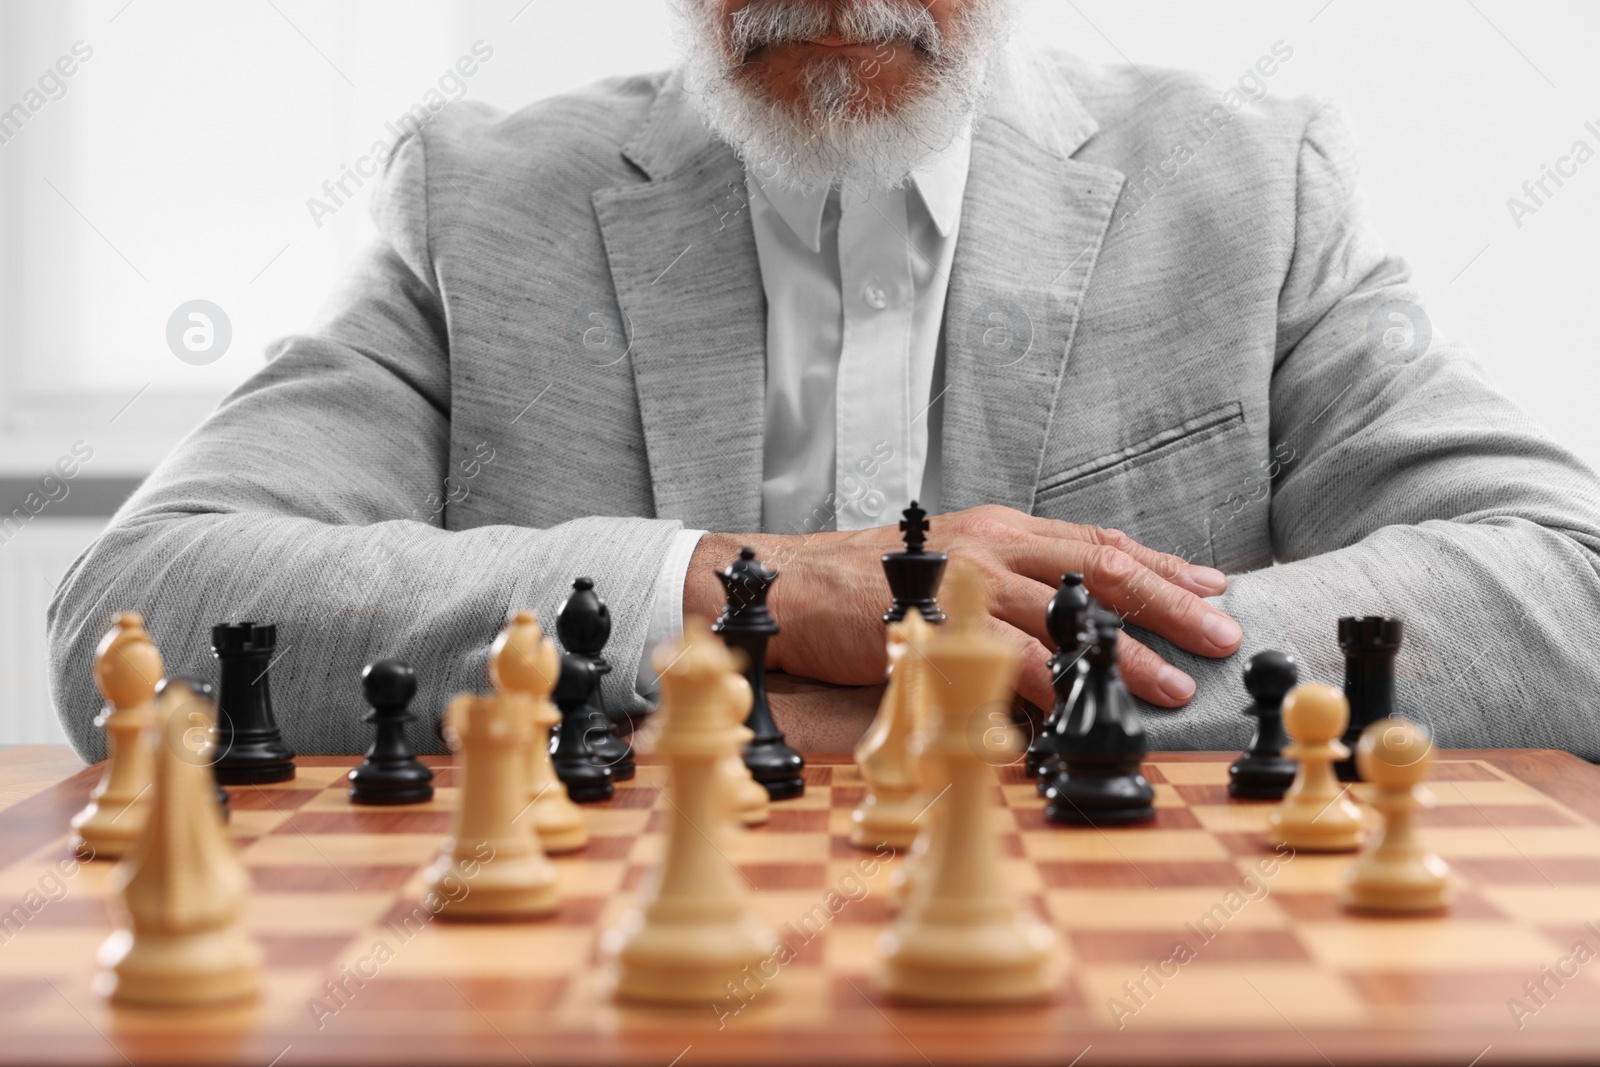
50, 138, 682, 760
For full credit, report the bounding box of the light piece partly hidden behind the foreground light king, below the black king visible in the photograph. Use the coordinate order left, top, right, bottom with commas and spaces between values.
850, 605, 933, 849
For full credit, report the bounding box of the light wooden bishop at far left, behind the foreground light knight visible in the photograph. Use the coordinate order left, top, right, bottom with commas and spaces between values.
72, 611, 165, 859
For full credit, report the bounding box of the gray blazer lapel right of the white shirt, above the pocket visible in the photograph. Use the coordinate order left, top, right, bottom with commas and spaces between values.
942, 59, 1123, 512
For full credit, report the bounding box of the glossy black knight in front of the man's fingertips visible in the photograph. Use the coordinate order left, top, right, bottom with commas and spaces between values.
1045, 614, 1155, 827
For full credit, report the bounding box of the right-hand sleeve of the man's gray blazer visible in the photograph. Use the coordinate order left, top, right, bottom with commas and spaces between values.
1147, 109, 1600, 758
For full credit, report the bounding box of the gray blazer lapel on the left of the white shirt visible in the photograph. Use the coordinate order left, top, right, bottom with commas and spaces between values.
594, 75, 766, 531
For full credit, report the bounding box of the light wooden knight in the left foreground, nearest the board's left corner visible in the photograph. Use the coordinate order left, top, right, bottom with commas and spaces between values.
94, 680, 261, 1006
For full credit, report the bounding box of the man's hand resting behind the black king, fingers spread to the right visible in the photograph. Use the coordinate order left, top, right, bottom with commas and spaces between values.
683, 506, 1242, 709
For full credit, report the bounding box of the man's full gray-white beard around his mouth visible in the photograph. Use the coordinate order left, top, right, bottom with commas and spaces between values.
674, 0, 1014, 190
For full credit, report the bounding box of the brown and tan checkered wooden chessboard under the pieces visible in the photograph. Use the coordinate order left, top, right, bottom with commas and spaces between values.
0, 750, 1600, 1067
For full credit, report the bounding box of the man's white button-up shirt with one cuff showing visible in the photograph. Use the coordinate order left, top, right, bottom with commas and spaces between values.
637, 126, 971, 694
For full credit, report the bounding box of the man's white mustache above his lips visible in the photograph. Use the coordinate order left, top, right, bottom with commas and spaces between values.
728, 0, 944, 59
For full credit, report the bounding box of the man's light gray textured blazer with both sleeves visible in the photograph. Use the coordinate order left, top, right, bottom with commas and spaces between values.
50, 49, 1600, 757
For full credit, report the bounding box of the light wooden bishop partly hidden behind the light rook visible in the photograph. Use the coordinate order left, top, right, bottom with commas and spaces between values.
490, 611, 589, 854
